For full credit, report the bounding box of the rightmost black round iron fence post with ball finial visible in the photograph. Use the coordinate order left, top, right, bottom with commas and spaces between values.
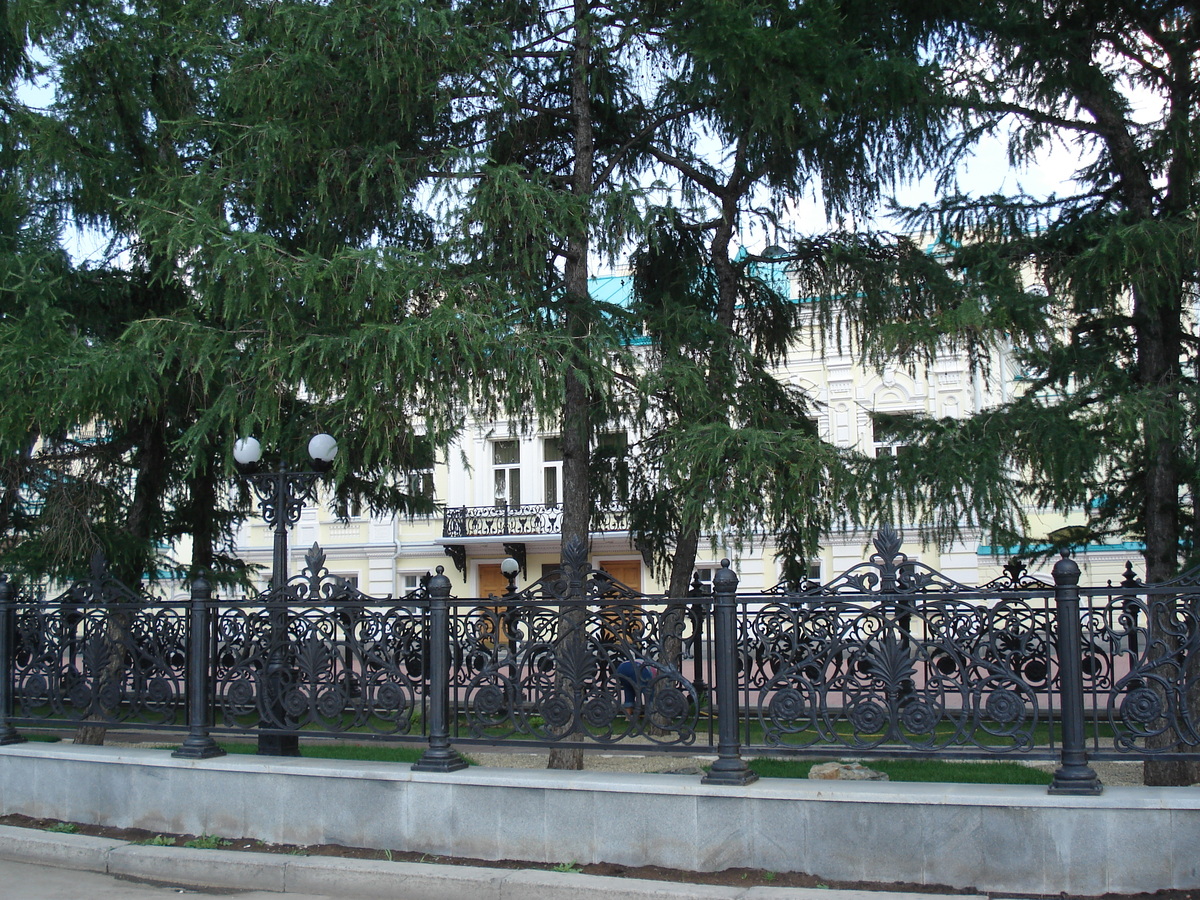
1048, 552, 1104, 794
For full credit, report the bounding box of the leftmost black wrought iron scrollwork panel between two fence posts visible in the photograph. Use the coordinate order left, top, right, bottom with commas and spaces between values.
13, 593, 187, 727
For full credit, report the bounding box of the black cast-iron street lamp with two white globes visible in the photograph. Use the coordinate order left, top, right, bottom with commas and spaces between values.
233, 434, 337, 756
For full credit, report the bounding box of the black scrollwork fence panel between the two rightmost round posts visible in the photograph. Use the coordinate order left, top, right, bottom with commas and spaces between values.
739, 594, 1054, 754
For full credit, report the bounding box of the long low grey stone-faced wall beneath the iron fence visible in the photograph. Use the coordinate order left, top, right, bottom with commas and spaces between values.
0, 744, 1200, 896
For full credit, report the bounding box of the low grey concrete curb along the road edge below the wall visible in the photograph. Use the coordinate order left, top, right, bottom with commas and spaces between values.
0, 826, 985, 900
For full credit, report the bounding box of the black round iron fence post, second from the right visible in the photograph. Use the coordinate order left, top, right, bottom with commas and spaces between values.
701, 559, 758, 785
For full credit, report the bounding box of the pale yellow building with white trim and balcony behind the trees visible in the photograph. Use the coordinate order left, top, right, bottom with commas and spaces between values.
229, 264, 1141, 596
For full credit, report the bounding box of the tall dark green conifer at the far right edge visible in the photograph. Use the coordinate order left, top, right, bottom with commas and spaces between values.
797, 0, 1200, 784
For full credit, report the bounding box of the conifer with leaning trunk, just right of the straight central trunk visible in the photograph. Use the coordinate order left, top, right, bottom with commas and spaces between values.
634, 0, 946, 596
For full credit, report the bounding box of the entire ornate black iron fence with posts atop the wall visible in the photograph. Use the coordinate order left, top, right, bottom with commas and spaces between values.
0, 529, 1200, 793
